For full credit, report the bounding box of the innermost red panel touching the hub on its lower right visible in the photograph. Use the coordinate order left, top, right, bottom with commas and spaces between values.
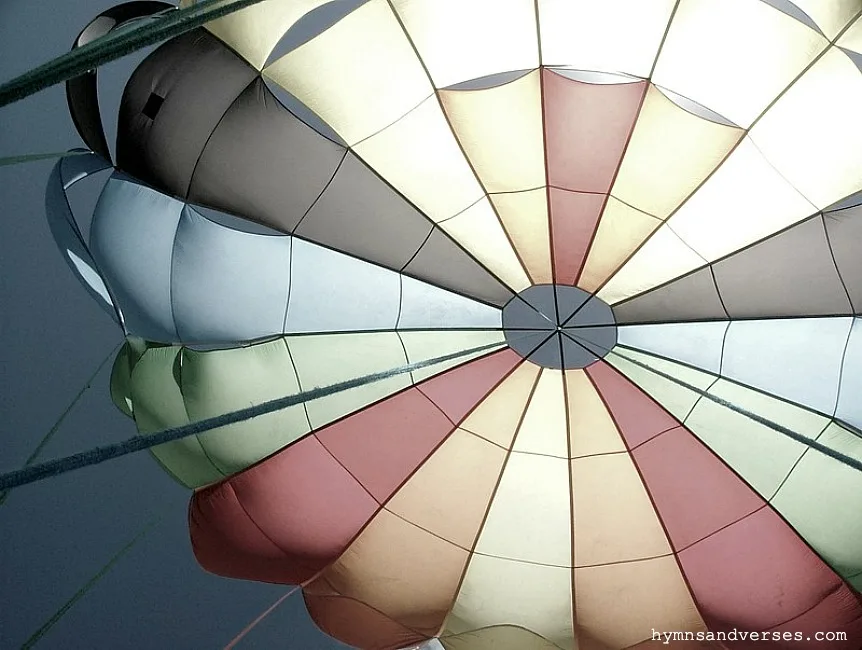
586, 361, 679, 449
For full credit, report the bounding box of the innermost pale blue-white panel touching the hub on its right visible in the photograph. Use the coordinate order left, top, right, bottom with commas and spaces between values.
617, 321, 728, 374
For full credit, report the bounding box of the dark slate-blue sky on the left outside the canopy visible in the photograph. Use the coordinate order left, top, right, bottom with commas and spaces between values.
0, 0, 346, 650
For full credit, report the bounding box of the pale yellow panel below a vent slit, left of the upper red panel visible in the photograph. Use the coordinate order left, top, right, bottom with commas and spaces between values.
439, 71, 545, 192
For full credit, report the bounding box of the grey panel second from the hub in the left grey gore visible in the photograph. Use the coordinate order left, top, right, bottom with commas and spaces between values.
296, 152, 433, 270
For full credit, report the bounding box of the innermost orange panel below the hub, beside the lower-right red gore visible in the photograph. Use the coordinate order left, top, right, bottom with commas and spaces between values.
566, 370, 626, 458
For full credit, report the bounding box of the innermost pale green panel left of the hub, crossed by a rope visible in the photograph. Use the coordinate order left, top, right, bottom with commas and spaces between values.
400, 330, 505, 383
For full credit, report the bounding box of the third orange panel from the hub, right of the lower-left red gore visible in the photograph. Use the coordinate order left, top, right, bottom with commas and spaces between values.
314, 510, 469, 636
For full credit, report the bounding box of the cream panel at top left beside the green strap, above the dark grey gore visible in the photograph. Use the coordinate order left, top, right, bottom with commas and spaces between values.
180, 0, 329, 70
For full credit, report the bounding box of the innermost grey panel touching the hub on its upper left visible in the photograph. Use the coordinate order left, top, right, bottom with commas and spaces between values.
404, 228, 515, 307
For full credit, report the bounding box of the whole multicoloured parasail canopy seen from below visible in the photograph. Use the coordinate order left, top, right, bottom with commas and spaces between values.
47, 0, 862, 650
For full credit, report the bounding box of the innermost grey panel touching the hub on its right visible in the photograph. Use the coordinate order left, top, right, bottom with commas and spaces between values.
612, 267, 727, 325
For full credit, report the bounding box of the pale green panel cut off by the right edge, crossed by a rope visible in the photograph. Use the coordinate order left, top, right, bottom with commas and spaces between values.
772, 423, 862, 588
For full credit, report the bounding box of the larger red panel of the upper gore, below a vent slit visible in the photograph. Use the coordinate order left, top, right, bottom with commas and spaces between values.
542, 69, 647, 194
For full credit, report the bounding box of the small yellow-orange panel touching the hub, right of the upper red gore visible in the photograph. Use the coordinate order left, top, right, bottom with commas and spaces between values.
578, 196, 661, 292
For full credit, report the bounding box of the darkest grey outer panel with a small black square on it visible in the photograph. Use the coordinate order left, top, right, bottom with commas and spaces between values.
117, 29, 257, 198
